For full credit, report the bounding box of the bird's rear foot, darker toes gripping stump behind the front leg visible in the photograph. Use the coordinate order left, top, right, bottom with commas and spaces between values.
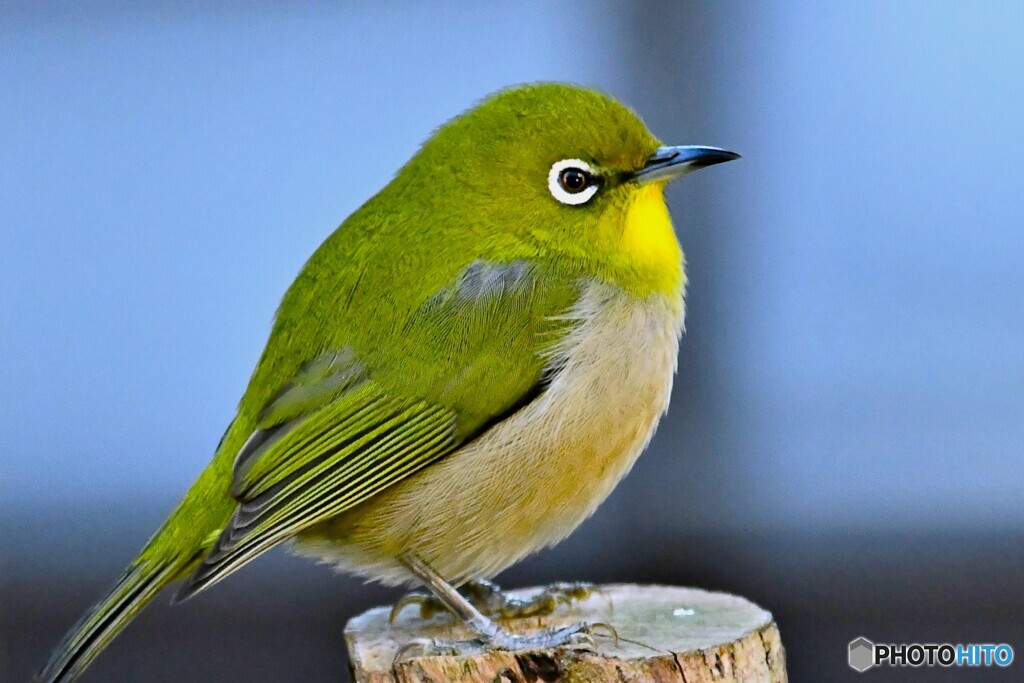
390, 581, 596, 622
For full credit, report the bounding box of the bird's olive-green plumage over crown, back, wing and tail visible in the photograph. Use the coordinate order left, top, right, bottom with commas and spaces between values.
41, 84, 733, 682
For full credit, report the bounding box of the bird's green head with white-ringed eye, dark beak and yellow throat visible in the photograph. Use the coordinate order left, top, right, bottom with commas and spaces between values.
387, 83, 738, 295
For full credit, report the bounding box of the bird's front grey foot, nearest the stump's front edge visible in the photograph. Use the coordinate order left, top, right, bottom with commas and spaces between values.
394, 623, 618, 664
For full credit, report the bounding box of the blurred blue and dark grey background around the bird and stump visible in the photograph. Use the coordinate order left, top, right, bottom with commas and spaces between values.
0, 0, 1024, 683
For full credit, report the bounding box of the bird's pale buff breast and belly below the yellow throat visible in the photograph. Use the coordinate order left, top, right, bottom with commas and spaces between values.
296, 285, 683, 585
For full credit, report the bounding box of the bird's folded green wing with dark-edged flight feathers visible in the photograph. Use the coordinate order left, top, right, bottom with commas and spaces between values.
176, 261, 578, 600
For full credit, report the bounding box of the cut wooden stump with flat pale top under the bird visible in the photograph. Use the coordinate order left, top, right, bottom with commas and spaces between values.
345, 585, 787, 683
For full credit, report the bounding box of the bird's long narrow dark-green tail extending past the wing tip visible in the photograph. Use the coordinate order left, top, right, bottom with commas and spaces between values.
36, 560, 186, 683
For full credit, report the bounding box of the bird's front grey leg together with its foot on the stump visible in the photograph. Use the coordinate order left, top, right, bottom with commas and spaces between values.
395, 553, 598, 660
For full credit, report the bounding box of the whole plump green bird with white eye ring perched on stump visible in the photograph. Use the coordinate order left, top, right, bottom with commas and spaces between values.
40, 84, 737, 683
